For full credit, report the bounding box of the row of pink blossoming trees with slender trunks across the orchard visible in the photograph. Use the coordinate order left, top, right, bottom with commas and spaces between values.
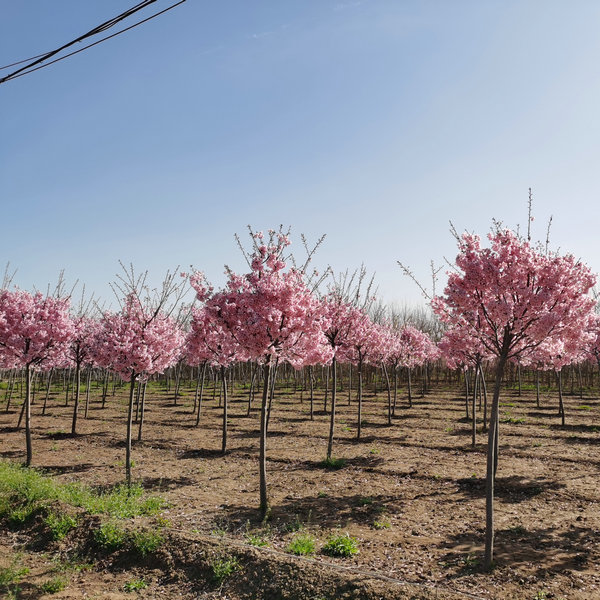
0, 224, 600, 565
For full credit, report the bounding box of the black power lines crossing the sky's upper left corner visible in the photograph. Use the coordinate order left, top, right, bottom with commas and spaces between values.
0, 0, 186, 84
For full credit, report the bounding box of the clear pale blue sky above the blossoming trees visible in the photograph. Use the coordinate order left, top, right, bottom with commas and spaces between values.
0, 0, 600, 304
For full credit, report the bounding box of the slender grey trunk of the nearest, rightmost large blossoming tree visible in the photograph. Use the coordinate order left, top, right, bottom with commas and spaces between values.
484, 344, 510, 569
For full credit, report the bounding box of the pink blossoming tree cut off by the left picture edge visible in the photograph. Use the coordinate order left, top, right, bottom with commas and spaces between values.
0, 290, 73, 466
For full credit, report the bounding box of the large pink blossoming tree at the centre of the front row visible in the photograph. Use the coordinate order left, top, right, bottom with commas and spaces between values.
190, 230, 324, 519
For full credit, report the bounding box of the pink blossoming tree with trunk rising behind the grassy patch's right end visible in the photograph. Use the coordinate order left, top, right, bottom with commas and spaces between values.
95, 275, 184, 485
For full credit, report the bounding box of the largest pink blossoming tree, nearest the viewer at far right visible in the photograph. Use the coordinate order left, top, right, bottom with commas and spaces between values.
432, 230, 595, 568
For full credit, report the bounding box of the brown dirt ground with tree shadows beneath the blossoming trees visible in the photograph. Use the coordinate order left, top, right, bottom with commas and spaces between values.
0, 380, 600, 600
